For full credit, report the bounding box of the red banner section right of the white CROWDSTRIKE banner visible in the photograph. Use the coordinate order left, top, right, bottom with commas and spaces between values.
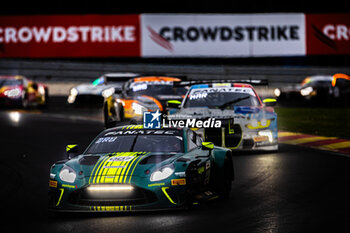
306, 14, 350, 55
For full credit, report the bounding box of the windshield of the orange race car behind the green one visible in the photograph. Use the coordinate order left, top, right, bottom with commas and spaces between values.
128, 82, 187, 96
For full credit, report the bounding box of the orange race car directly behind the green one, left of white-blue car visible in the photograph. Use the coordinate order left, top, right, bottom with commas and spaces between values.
103, 76, 187, 128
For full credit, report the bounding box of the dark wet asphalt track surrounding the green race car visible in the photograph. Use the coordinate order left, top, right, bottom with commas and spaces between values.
0, 110, 350, 233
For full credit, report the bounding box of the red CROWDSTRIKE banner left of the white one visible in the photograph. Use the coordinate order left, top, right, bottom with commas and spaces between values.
0, 15, 141, 58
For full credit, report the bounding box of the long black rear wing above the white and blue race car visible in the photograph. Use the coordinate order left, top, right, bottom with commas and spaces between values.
174, 79, 269, 87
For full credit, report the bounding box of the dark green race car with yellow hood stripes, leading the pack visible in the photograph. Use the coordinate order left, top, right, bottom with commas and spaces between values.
49, 125, 234, 211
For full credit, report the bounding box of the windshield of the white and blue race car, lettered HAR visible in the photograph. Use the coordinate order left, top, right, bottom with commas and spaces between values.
184, 87, 260, 108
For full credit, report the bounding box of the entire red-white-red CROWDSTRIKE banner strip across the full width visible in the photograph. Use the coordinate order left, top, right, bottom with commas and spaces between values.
0, 13, 350, 58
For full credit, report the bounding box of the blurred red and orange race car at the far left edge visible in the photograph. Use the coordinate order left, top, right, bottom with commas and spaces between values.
0, 75, 48, 108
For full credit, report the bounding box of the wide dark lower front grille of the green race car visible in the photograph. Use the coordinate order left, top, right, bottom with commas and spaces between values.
69, 185, 157, 206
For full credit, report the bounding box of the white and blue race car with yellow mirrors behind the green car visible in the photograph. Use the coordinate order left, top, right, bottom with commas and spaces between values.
168, 82, 278, 150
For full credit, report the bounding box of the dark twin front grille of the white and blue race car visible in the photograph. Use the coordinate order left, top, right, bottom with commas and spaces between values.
205, 124, 242, 147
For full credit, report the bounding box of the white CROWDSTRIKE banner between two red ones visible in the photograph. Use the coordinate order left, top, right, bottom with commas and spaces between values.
141, 14, 306, 57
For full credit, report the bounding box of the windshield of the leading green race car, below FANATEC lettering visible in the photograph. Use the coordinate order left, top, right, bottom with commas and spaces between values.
86, 135, 183, 154
